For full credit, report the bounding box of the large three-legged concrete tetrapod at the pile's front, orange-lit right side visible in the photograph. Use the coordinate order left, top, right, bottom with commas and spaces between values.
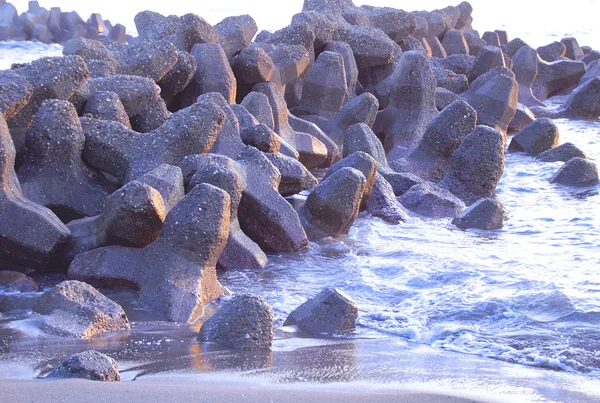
69, 184, 230, 323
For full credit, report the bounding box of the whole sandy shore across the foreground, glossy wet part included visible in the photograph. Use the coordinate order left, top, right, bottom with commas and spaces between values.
0, 339, 600, 403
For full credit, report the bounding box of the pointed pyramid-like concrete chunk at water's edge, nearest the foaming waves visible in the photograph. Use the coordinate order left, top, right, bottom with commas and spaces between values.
283, 288, 358, 336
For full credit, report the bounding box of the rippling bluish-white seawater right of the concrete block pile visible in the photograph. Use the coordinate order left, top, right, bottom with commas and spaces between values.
218, 121, 600, 372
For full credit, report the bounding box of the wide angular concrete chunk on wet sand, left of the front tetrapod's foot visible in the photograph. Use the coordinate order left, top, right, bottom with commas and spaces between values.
34, 280, 131, 339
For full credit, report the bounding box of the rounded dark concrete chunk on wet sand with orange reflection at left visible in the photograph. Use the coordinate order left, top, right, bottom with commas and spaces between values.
198, 294, 273, 351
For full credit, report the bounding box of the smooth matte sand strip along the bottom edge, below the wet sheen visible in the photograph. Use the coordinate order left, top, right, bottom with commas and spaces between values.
0, 377, 486, 403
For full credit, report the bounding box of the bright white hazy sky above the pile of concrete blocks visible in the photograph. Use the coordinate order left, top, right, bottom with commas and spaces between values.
10, 0, 600, 48
